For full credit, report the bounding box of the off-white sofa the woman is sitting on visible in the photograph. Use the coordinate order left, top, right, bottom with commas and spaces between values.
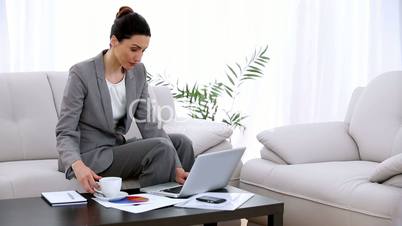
0, 72, 236, 199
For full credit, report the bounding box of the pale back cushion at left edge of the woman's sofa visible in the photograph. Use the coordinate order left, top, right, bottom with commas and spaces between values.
0, 73, 57, 161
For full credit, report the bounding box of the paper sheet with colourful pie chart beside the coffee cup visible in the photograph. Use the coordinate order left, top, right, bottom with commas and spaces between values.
93, 194, 187, 213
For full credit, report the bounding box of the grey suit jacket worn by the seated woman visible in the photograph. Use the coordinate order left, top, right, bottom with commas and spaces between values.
56, 50, 180, 179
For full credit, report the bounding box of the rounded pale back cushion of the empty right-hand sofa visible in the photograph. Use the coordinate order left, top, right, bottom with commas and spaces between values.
349, 71, 402, 162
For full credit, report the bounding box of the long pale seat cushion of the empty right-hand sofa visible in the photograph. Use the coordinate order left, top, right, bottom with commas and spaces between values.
240, 159, 401, 218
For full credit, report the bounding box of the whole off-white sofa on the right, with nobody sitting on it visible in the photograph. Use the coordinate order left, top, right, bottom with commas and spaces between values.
240, 71, 402, 226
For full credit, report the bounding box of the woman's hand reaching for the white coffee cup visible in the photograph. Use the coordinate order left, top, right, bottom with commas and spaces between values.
71, 160, 102, 193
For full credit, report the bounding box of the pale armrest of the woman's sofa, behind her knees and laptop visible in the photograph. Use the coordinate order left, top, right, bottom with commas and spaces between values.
163, 118, 233, 155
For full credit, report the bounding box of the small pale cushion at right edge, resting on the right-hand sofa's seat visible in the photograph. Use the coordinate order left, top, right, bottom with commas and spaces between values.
370, 153, 402, 183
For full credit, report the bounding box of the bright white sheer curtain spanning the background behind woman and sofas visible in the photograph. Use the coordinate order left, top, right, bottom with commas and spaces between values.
0, 0, 402, 159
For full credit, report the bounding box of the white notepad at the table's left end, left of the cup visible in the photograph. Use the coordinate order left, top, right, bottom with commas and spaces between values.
42, 191, 87, 206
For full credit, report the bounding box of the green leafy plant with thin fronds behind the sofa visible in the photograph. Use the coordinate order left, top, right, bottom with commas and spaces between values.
147, 46, 269, 130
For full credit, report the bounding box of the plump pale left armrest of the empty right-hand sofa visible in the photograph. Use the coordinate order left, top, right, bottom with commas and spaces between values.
257, 122, 359, 164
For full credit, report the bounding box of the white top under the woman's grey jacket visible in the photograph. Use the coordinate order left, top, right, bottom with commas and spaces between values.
106, 76, 127, 127
